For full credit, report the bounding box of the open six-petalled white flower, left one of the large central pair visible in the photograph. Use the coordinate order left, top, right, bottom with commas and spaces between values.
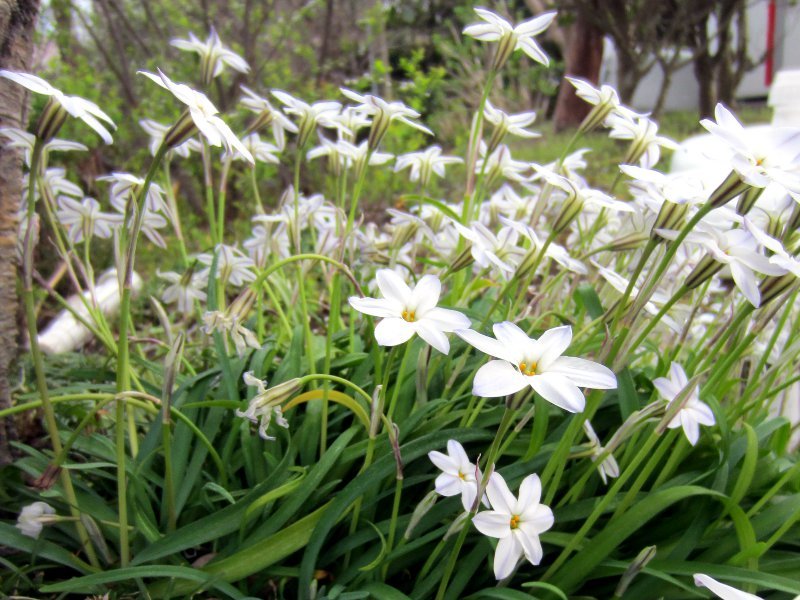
350, 269, 470, 354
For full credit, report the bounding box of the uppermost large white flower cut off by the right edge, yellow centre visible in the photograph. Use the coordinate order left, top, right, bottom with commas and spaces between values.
700, 104, 800, 192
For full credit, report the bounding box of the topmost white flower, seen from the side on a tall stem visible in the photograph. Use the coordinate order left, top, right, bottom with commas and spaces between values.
464, 8, 556, 70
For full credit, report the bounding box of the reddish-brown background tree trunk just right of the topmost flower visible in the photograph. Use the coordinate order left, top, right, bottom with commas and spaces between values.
553, 8, 603, 131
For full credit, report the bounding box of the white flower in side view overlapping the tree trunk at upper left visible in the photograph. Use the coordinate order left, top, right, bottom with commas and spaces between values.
0, 69, 114, 144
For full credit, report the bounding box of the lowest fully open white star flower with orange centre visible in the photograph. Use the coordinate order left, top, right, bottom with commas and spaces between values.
472, 473, 554, 580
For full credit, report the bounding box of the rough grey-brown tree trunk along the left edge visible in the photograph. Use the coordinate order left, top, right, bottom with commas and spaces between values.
0, 0, 39, 464
